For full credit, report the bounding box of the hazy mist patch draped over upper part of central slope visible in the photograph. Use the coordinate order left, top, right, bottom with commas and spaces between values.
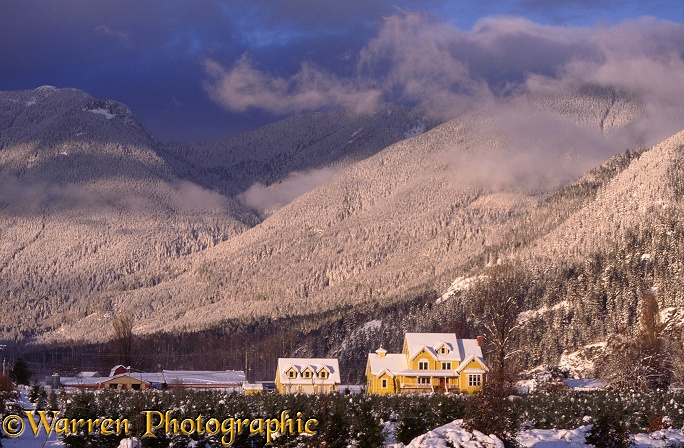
446, 98, 629, 193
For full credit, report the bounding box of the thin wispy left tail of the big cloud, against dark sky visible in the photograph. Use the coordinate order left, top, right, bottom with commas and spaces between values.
204, 56, 380, 114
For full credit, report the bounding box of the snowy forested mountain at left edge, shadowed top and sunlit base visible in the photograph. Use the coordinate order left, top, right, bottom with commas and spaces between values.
0, 87, 251, 339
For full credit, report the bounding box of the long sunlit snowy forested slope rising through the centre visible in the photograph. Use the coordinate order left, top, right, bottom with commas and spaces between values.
46, 89, 652, 342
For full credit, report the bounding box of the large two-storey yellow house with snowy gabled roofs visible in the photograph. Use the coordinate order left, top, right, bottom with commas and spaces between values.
366, 333, 489, 394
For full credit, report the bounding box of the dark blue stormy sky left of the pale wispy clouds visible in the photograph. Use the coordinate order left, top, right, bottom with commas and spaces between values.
0, 0, 440, 139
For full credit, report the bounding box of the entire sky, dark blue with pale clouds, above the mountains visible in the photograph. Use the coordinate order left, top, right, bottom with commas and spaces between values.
0, 0, 684, 140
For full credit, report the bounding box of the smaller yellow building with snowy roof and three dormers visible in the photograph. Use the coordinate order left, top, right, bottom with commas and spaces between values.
275, 358, 340, 394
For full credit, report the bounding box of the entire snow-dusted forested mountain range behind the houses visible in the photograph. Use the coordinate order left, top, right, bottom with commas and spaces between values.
0, 86, 684, 378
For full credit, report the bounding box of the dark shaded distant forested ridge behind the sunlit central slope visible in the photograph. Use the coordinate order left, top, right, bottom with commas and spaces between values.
161, 105, 437, 200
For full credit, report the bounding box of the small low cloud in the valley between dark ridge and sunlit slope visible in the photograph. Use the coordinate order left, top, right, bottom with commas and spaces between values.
237, 167, 342, 215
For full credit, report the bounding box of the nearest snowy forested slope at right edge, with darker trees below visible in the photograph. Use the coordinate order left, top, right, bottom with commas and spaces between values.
442, 131, 684, 367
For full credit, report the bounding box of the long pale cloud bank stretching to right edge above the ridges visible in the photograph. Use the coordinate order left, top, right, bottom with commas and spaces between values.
205, 12, 684, 147
